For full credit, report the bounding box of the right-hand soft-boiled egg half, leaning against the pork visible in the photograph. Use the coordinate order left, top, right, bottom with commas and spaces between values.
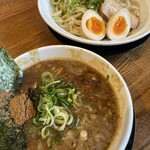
106, 8, 131, 40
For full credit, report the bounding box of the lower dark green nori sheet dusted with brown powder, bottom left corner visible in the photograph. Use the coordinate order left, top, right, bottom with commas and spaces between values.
0, 93, 27, 150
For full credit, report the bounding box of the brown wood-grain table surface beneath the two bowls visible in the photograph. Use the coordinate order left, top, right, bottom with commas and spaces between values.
0, 0, 150, 150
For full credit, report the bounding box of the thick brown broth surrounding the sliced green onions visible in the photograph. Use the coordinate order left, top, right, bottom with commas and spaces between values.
22, 59, 118, 150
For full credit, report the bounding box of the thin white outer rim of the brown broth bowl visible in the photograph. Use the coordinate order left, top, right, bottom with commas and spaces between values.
15, 45, 134, 150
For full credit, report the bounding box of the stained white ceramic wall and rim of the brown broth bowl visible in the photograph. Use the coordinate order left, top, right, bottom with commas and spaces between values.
15, 45, 133, 150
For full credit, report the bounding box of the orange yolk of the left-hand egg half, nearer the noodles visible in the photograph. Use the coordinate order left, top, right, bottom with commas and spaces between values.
86, 17, 105, 35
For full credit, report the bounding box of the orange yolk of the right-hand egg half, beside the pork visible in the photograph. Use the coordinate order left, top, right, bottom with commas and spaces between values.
111, 16, 127, 35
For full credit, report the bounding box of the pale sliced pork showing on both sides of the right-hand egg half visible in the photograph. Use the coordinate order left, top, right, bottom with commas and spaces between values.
100, 0, 140, 28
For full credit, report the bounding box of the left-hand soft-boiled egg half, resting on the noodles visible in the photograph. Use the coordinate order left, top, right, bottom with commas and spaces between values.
81, 10, 106, 40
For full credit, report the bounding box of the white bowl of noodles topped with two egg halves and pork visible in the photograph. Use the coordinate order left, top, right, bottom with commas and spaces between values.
38, 0, 150, 46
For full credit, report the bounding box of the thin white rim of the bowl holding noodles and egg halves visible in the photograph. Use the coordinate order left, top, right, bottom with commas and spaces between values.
37, 0, 150, 46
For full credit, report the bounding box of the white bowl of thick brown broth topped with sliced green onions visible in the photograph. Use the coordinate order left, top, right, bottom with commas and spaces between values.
11, 45, 133, 150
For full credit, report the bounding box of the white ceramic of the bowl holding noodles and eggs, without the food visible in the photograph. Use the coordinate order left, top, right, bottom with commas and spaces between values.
38, 0, 150, 46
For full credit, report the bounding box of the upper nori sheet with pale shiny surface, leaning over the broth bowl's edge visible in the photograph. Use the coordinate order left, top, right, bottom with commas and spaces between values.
0, 47, 24, 92
